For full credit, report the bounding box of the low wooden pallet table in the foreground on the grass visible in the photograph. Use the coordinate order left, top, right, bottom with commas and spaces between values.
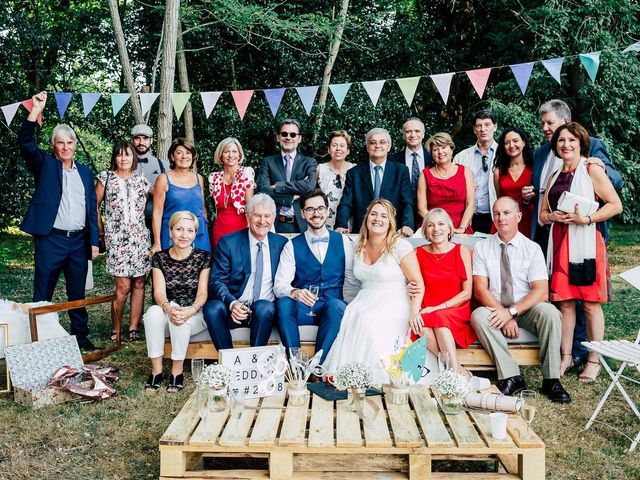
160, 386, 545, 480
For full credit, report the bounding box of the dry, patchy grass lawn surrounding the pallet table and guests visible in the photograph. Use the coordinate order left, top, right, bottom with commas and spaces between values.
0, 225, 640, 480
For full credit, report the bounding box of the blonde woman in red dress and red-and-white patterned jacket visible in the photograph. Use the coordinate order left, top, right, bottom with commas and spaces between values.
209, 137, 256, 248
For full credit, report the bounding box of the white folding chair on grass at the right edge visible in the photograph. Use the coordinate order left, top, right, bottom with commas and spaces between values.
582, 330, 640, 452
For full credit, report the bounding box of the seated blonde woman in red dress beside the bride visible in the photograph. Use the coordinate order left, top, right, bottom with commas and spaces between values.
416, 208, 476, 378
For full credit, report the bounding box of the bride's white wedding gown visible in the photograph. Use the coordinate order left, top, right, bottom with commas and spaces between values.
324, 239, 437, 385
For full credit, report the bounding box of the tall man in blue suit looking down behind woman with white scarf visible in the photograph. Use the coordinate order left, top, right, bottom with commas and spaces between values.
522, 99, 622, 366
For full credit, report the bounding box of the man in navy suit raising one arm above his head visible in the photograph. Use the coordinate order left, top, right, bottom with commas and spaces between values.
18, 91, 98, 350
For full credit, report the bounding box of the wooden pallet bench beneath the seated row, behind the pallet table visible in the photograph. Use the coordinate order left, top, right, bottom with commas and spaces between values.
164, 340, 540, 371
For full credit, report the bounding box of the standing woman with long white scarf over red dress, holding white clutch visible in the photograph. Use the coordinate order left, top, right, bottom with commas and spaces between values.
540, 122, 622, 383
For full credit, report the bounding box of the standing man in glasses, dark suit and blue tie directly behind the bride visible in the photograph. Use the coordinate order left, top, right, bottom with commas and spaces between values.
334, 128, 415, 233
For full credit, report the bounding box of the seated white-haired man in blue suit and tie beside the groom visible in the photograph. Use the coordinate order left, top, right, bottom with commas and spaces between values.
203, 193, 287, 350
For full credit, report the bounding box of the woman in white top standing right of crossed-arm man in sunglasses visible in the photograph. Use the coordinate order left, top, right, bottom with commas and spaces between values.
318, 130, 355, 229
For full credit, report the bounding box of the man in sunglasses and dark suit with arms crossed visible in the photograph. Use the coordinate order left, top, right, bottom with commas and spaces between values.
258, 118, 318, 233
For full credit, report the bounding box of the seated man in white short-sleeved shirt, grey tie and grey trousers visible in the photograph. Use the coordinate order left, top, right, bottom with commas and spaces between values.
471, 197, 571, 403
